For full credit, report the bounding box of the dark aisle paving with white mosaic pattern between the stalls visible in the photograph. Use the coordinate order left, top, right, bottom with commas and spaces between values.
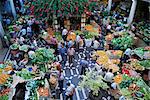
63, 47, 95, 100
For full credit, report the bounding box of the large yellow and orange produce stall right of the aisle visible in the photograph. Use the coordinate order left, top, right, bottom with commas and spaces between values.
91, 50, 123, 72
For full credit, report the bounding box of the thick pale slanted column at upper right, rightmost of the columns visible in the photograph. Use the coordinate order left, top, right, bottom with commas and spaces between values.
128, 0, 137, 24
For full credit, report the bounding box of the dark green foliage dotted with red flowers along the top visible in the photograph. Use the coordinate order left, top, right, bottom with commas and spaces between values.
30, 0, 97, 17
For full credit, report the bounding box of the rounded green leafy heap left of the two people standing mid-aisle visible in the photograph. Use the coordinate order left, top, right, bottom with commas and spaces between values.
32, 48, 55, 64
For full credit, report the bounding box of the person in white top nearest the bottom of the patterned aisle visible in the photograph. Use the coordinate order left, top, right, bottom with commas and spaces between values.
65, 82, 75, 100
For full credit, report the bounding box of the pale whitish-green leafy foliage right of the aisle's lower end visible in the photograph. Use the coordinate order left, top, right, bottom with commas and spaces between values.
79, 70, 109, 95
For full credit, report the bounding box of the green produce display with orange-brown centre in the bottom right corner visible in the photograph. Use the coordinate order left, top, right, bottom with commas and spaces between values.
119, 74, 150, 100
